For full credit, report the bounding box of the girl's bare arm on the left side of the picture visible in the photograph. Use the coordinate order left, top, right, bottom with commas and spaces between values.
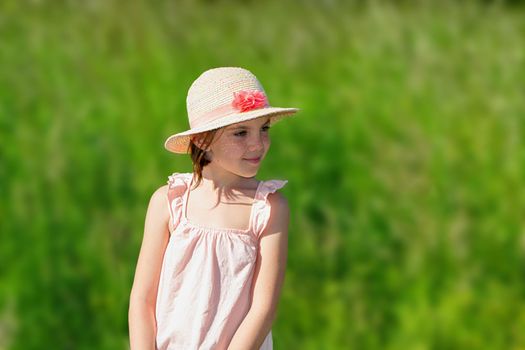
128, 185, 169, 350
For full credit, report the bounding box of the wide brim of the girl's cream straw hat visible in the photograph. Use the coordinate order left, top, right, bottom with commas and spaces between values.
164, 107, 299, 154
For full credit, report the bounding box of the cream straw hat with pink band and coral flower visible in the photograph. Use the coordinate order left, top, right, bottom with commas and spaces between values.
164, 67, 299, 153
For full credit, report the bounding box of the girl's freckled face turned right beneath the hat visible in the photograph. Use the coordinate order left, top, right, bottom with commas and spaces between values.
205, 117, 270, 177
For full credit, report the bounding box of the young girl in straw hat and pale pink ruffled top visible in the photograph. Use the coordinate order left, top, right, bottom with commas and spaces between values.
129, 67, 298, 350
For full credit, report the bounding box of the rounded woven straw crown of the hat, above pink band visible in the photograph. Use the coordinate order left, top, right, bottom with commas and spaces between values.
186, 67, 265, 128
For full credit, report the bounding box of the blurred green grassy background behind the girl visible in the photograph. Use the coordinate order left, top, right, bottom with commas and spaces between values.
0, 0, 525, 350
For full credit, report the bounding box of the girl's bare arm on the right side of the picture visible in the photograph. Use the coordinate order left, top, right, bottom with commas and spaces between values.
228, 192, 290, 350
